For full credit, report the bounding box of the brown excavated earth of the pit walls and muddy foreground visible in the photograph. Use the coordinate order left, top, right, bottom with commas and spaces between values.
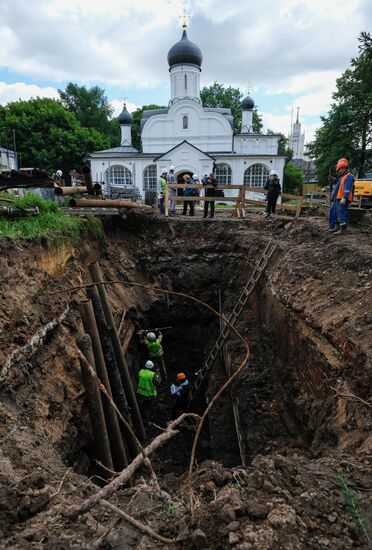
0, 212, 372, 550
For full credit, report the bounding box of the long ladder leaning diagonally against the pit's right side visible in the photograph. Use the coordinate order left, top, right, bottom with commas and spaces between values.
190, 243, 276, 402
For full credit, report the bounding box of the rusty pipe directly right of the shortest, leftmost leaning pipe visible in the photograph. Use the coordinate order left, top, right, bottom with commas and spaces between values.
79, 300, 128, 470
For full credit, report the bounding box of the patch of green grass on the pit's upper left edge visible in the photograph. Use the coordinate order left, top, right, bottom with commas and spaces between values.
0, 193, 102, 249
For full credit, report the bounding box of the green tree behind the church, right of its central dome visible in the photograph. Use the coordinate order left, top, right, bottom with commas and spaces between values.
200, 82, 263, 134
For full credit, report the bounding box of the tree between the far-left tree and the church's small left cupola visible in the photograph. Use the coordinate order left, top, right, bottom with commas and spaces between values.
58, 82, 114, 136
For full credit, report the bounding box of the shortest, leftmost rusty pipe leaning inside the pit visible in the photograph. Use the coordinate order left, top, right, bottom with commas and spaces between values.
76, 334, 113, 477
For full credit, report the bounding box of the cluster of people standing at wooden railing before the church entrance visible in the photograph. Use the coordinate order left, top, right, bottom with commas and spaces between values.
158, 166, 219, 218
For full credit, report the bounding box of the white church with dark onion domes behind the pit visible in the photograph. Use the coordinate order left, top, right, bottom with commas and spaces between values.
88, 28, 285, 198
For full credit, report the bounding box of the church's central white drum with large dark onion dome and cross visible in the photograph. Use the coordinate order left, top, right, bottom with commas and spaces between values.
168, 23, 203, 103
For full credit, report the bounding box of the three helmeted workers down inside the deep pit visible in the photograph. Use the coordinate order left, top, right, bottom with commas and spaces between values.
137, 331, 190, 425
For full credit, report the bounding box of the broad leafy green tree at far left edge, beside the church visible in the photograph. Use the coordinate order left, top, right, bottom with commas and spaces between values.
0, 97, 109, 175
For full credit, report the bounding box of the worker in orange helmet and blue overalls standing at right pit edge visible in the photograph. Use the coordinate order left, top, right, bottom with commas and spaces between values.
328, 158, 355, 235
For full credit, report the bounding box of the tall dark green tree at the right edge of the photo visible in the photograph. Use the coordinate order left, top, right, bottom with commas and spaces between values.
307, 33, 372, 183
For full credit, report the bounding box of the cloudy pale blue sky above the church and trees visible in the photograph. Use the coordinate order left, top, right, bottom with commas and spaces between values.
0, 0, 372, 142
